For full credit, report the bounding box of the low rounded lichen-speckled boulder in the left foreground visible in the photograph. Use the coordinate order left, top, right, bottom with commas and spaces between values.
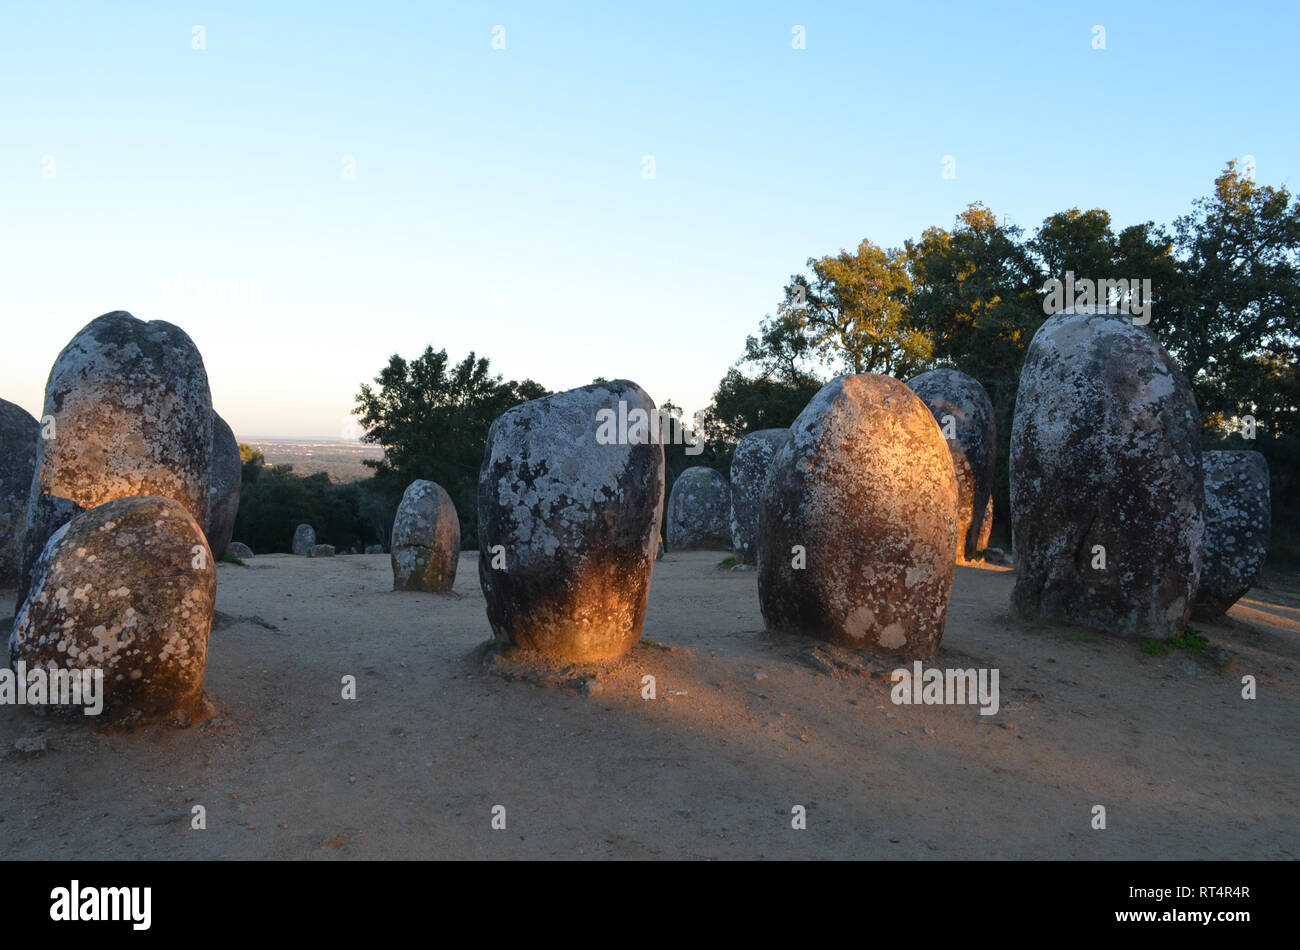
9, 495, 217, 723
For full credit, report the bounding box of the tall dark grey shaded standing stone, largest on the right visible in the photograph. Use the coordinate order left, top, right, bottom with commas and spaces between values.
1010, 307, 1205, 639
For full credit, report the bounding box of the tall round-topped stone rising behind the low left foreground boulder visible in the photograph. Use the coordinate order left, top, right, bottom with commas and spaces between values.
18, 311, 212, 598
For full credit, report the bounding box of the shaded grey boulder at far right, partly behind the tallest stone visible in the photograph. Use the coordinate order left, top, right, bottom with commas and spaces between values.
1192, 451, 1273, 620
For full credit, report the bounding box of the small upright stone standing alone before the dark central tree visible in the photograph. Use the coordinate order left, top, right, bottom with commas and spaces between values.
390, 478, 460, 591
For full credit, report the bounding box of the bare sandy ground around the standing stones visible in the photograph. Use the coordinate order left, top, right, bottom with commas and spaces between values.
0, 552, 1300, 859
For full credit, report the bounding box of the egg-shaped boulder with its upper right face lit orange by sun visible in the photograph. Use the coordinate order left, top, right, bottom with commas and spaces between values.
758, 373, 957, 658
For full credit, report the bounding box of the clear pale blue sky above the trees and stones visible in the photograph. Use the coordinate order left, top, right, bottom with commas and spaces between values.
0, 0, 1300, 437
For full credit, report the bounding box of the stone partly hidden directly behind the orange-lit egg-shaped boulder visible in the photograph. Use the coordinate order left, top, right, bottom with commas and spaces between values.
907, 369, 997, 560
